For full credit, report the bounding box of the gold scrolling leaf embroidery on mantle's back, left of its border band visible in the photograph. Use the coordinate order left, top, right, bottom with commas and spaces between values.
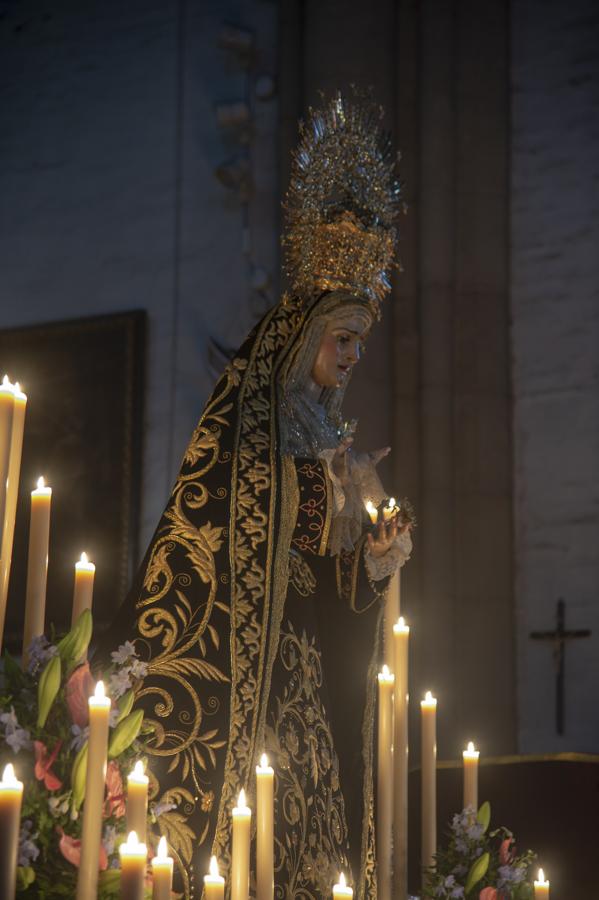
131, 359, 247, 896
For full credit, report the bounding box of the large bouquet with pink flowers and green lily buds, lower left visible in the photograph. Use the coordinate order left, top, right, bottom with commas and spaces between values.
0, 610, 155, 900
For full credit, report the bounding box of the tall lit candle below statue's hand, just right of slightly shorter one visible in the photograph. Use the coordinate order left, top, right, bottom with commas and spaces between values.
393, 617, 410, 900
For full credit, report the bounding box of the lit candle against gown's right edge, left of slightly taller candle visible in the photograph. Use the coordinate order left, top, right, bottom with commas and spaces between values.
376, 665, 395, 900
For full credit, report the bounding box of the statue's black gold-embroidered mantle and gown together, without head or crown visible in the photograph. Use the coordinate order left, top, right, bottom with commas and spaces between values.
100, 292, 385, 900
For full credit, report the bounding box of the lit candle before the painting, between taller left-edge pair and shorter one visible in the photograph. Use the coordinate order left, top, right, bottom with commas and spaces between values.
23, 477, 52, 668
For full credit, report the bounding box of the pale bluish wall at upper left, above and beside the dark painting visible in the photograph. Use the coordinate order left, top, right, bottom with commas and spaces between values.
0, 0, 278, 568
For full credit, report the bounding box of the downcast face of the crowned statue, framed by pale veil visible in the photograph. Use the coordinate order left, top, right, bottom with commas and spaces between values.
311, 313, 371, 387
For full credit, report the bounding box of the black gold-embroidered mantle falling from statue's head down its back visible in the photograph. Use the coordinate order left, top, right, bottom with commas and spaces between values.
112, 293, 370, 896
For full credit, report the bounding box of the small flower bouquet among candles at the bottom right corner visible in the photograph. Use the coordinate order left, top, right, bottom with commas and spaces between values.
423, 802, 535, 900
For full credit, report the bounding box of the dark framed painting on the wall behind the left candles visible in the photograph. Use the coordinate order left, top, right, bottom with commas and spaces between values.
0, 311, 146, 654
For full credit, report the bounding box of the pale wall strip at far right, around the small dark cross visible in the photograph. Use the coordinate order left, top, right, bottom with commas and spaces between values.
511, 0, 599, 752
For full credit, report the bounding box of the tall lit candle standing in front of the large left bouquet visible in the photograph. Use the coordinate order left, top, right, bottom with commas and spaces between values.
77, 681, 110, 900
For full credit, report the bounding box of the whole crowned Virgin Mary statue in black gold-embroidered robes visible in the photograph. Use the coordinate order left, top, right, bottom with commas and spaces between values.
101, 96, 411, 900
